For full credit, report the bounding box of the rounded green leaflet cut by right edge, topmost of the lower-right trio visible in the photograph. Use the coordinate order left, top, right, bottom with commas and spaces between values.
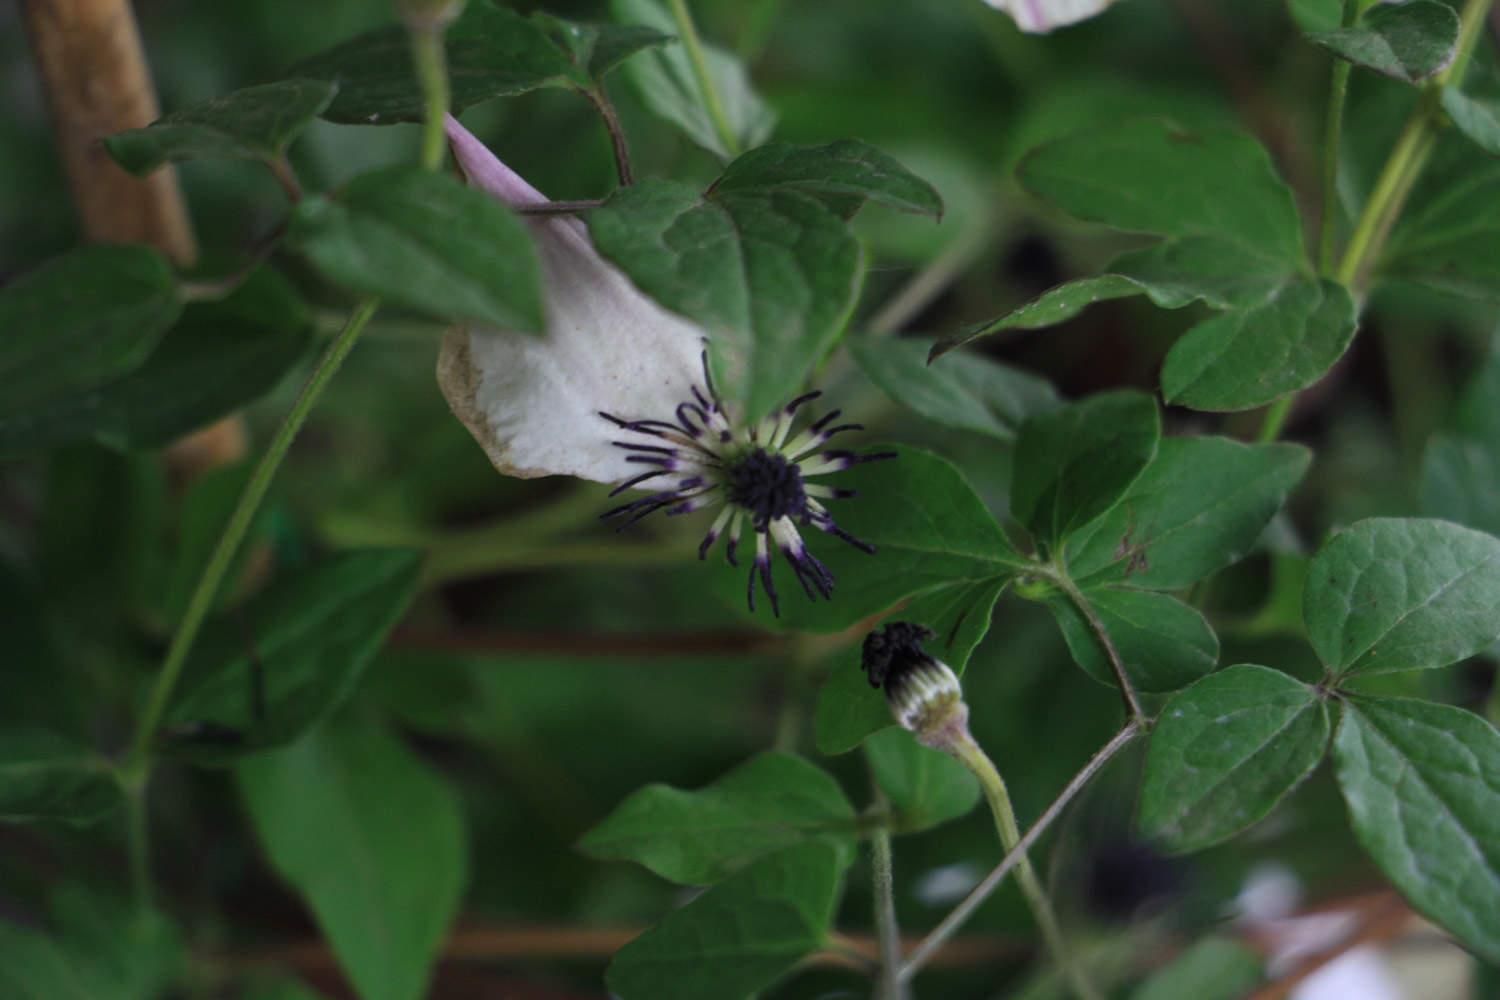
1302, 517, 1500, 675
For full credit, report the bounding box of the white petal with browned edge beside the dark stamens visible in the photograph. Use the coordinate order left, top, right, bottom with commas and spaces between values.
438, 115, 704, 483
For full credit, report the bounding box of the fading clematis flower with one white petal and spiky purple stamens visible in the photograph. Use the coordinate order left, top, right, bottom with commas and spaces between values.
438, 115, 894, 615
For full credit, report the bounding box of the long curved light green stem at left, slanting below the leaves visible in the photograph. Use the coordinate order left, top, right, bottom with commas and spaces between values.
123, 298, 380, 779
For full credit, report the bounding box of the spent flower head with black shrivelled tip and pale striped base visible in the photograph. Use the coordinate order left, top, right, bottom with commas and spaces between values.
861, 622, 969, 753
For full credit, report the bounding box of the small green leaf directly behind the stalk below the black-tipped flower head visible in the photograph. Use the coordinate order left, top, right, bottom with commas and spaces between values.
864, 729, 980, 834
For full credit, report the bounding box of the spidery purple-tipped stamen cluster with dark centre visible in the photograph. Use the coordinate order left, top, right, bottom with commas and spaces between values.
600, 354, 896, 615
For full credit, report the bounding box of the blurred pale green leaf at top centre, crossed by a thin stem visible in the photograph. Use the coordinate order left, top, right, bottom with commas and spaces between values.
609, 0, 776, 160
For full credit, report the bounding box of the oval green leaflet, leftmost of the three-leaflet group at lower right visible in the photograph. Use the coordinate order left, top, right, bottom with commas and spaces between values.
1137, 664, 1331, 852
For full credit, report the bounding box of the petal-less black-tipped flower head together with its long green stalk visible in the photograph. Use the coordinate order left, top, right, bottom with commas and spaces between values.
861, 622, 1103, 1000
